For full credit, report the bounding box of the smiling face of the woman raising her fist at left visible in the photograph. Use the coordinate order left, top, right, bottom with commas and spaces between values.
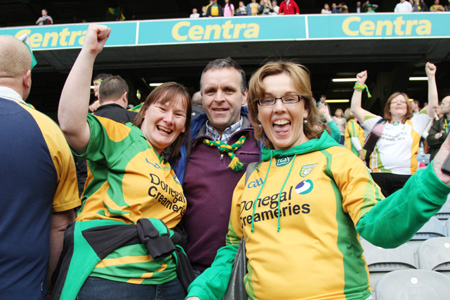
141, 97, 186, 155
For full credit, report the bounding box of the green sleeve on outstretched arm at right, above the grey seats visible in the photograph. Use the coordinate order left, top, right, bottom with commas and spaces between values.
356, 164, 450, 248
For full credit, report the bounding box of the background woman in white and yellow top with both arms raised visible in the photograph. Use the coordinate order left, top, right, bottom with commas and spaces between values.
351, 63, 438, 197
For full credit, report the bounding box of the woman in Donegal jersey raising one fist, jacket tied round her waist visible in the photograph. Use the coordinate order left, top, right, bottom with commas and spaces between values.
53, 25, 193, 300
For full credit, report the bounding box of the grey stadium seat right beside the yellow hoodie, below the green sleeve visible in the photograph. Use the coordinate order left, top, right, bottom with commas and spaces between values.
361, 239, 418, 288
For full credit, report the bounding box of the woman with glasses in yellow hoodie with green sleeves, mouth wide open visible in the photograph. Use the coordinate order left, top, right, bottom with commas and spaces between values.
188, 61, 450, 300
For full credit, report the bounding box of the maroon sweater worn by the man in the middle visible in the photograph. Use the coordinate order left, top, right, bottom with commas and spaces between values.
183, 128, 260, 271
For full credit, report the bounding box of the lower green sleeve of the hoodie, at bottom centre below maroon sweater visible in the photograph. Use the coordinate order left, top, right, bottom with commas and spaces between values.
186, 244, 238, 300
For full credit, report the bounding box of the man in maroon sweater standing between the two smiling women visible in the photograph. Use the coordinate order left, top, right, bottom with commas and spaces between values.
172, 58, 260, 274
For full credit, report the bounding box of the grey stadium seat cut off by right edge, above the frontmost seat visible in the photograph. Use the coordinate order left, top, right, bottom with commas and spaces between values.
417, 237, 450, 276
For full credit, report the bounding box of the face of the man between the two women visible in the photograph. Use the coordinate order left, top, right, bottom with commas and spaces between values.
201, 68, 247, 134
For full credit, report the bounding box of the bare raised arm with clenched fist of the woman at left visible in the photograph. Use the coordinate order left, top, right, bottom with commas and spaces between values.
58, 24, 111, 153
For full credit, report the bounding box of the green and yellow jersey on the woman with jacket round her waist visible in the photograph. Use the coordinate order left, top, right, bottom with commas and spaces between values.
75, 114, 186, 284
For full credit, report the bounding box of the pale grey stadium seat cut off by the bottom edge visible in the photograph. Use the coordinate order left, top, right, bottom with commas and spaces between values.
373, 270, 450, 300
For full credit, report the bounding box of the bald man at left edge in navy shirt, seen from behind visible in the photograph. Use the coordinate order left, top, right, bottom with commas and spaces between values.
0, 35, 81, 299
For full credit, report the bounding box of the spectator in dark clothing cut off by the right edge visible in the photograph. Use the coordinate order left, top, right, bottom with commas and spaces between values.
427, 96, 450, 161
